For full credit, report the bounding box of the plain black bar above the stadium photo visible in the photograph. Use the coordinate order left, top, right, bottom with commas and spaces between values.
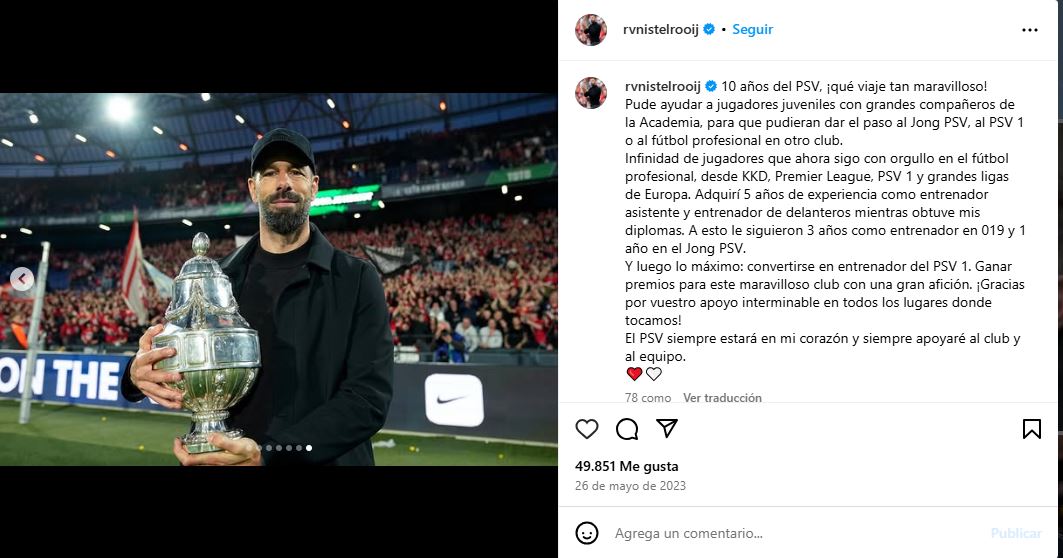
6, 9, 557, 92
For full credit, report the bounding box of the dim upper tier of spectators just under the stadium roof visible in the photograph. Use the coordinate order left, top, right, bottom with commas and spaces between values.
0, 121, 556, 216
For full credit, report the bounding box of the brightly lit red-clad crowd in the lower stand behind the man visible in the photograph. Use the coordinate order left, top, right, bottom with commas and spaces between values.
0, 209, 558, 361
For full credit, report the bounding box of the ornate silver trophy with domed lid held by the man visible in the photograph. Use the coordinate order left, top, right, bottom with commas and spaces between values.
152, 233, 261, 454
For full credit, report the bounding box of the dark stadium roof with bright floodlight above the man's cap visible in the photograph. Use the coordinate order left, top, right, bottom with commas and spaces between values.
0, 92, 557, 176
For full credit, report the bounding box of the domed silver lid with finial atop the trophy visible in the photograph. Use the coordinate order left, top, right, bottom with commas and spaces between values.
166, 233, 248, 329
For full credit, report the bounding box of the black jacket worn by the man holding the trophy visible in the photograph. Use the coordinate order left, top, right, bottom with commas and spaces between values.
121, 223, 394, 466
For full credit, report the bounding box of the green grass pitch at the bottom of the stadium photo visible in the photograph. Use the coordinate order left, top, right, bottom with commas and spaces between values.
0, 400, 557, 466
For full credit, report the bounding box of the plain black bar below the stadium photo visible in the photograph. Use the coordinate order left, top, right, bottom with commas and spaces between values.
14, 466, 557, 544
